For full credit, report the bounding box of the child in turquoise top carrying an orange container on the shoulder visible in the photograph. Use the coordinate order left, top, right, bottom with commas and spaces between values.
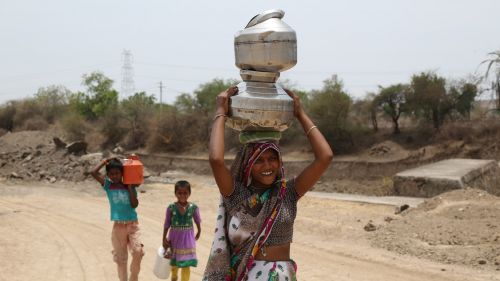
91, 158, 144, 281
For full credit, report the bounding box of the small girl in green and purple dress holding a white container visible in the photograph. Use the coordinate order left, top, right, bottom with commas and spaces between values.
162, 180, 201, 281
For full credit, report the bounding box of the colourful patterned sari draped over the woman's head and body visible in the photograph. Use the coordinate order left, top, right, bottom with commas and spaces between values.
203, 143, 296, 281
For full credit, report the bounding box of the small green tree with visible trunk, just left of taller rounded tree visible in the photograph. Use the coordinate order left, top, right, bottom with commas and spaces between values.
375, 84, 409, 134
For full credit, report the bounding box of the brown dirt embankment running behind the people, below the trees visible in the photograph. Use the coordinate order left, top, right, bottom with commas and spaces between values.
0, 131, 496, 196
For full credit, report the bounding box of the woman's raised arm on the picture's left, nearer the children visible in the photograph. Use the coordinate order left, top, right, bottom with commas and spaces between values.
208, 87, 238, 196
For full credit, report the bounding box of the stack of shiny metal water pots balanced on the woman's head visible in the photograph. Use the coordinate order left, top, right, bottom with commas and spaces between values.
226, 10, 297, 132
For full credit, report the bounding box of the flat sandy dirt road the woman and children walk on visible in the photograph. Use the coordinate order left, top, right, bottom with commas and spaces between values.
0, 175, 500, 281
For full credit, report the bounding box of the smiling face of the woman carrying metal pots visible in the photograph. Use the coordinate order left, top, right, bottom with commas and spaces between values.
251, 149, 281, 187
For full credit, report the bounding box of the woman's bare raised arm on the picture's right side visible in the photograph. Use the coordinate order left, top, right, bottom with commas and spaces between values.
285, 90, 333, 196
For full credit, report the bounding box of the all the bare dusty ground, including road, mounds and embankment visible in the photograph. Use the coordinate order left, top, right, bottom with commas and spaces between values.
0, 131, 500, 281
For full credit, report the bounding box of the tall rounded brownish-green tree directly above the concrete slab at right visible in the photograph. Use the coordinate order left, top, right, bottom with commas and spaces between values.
408, 72, 453, 129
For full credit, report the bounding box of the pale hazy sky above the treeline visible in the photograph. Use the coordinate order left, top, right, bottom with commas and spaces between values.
0, 0, 500, 102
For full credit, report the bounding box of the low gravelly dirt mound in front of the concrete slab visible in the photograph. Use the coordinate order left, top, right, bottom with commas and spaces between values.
371, 189, 500, 270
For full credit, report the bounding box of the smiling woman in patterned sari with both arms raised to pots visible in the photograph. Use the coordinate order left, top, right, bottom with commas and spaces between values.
203, 87, 333, 281
